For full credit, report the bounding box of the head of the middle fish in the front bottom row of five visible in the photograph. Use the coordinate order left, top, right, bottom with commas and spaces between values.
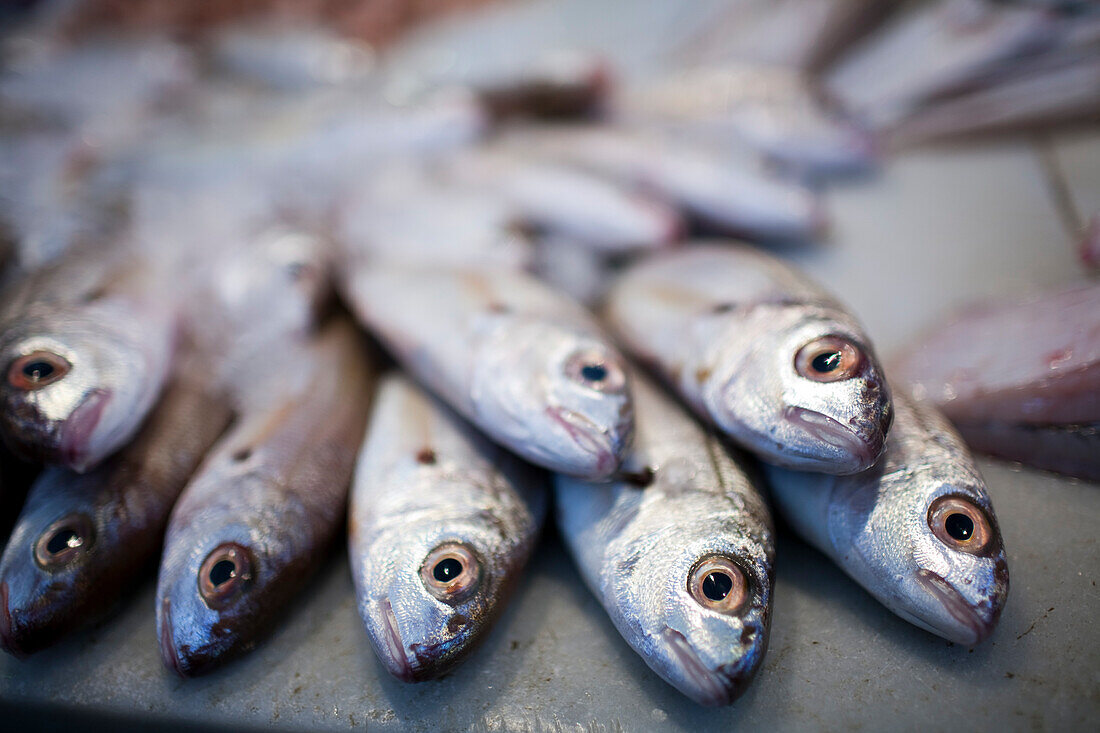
352, 483, 530, 682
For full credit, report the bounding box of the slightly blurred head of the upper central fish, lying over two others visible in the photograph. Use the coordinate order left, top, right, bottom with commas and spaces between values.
473, 318, 634, 479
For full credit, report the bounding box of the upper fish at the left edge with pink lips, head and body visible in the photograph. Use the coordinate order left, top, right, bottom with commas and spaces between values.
0, 248, 178, 472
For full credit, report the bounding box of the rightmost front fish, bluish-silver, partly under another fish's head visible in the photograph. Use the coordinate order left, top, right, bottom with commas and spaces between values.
765, 391, 1009, 646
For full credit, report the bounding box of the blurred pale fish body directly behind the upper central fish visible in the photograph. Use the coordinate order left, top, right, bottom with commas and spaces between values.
332, 164, 535, 270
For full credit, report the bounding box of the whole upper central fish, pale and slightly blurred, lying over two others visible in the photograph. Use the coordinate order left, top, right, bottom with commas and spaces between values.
342, 266, 634, 479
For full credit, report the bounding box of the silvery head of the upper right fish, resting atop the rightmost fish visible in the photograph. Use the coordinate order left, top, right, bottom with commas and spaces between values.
712, 307, 893, 474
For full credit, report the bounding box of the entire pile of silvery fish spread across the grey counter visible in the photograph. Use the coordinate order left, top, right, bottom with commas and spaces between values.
0, 0, 1100, 704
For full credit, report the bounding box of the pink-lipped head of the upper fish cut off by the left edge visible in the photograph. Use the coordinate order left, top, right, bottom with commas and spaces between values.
0, 307, 173, 472
